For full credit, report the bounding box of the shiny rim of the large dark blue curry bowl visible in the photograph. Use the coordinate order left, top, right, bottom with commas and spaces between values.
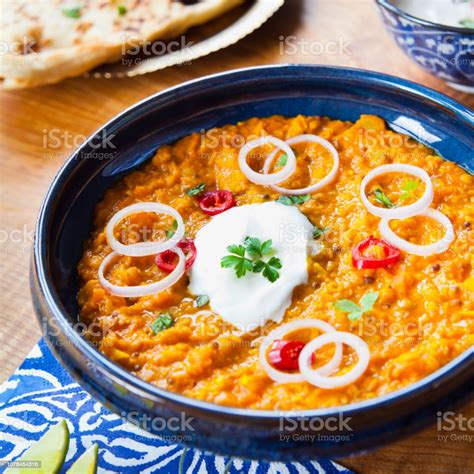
32, 64, 474, 421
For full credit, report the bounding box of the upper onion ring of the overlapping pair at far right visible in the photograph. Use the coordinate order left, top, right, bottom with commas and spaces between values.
360, 163, 434, 219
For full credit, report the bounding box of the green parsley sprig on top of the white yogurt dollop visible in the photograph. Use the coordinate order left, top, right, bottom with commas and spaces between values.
221, 237, 281, 283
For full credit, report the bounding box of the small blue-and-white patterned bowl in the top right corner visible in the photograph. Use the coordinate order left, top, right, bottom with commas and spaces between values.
376, 0, 474, 93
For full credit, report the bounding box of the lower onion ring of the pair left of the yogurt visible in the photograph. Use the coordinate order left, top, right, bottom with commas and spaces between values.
98, 247, 186, 298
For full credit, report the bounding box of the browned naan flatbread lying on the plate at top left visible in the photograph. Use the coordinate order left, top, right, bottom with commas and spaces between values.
0, 0, 243, 89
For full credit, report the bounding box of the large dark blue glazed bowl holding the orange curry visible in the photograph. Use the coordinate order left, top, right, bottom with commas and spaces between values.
31, 65, 474, 460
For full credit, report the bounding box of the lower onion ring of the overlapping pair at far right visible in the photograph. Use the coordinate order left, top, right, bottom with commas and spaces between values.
379, 209, 454, 257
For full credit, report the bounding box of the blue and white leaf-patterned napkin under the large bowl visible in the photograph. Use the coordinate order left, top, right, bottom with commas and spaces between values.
0, 340, 351, 474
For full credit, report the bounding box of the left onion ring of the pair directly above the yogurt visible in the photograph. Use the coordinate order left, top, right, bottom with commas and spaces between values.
239, 135, 296, 185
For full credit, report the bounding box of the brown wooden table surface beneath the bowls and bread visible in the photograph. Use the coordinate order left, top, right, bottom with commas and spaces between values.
0, 0, 474, 473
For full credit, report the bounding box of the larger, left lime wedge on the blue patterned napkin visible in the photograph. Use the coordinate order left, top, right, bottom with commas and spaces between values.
5, 420, 69, 474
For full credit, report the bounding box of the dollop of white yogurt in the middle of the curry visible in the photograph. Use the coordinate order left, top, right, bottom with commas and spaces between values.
189, 202, 313, 332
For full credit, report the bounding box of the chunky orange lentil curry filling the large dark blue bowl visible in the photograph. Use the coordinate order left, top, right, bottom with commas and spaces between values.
78, 115, 474, 410
